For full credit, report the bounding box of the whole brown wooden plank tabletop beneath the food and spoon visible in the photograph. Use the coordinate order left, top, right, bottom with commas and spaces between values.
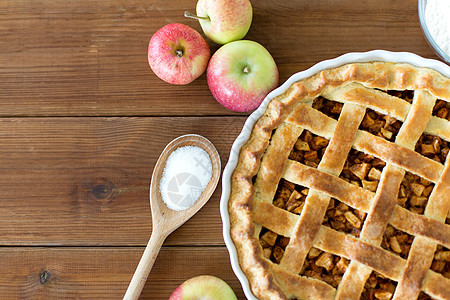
0, 0, 442, 299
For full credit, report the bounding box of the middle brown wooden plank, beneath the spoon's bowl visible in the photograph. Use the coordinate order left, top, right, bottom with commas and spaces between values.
0, 117, 245, 246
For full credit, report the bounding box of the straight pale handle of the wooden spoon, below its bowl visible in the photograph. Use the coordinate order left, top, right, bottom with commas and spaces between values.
123, 230, 167, 300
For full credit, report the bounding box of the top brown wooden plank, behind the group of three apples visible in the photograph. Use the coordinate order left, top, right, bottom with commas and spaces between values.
0, 0, 436, 116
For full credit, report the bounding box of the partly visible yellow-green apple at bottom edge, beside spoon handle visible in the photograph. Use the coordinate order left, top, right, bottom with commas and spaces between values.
169, 275, 237, 300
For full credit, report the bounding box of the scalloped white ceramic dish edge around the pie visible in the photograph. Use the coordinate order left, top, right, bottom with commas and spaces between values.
220, 50, 450, 299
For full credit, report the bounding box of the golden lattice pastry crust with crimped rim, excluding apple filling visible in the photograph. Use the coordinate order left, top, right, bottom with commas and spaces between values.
229, 62, 450, 299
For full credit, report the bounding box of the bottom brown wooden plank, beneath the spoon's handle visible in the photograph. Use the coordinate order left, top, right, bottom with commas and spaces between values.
0, 247, 245, 299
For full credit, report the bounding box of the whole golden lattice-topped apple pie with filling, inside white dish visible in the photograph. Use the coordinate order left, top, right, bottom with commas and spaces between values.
228, 62, 450, 300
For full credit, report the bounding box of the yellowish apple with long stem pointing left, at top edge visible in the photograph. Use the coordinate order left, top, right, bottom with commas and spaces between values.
184, 0, 253, 45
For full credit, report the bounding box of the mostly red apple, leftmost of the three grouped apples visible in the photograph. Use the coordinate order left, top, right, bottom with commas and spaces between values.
148, 23, 211, 84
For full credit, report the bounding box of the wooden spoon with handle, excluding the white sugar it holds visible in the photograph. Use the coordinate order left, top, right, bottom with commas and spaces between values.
123, 134, 220, 300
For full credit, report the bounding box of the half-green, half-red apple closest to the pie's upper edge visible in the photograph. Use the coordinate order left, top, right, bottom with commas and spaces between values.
206, 40, 278, 112
